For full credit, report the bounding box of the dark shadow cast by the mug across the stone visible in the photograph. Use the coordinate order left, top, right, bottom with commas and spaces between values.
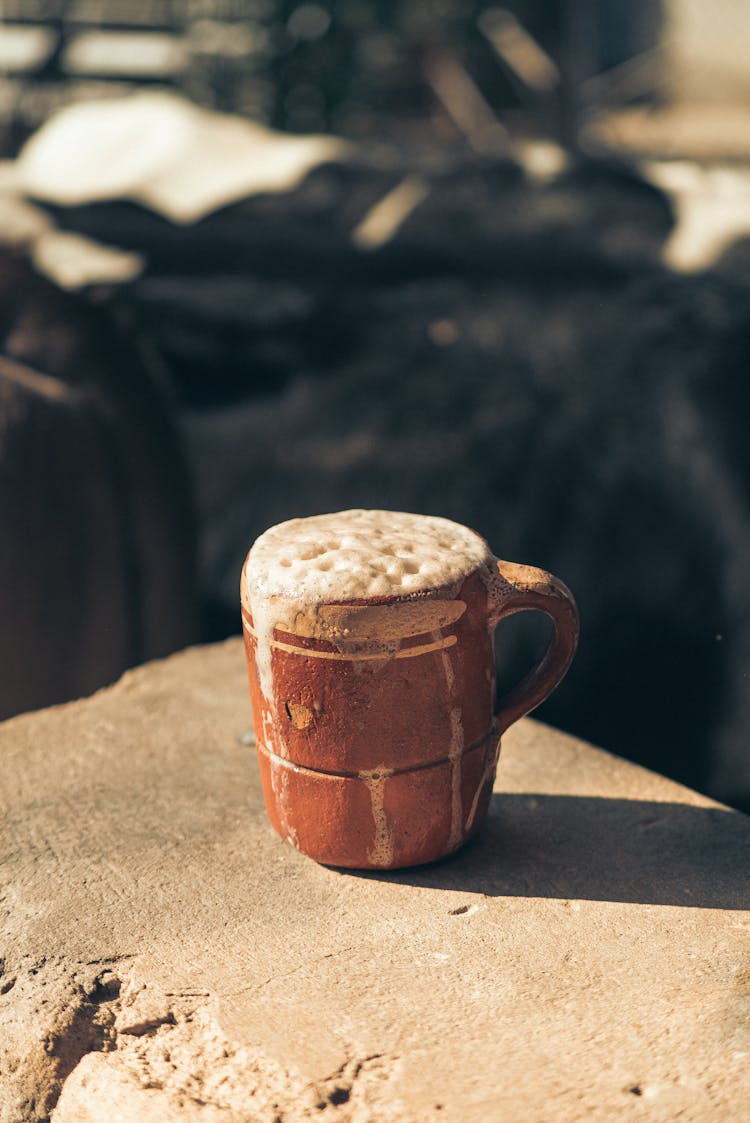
360, 794, 750, 910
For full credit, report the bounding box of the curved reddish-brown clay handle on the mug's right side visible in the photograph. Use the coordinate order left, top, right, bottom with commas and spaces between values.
490, 560, 578, 736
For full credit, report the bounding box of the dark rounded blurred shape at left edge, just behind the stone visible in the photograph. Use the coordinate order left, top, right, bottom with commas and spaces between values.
0, 252, 196, 718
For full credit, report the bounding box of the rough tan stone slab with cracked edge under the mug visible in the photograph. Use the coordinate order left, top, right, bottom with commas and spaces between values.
0, 641, 750, 1123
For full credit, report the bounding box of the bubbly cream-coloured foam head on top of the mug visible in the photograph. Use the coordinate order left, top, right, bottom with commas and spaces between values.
245, 511, 492, 606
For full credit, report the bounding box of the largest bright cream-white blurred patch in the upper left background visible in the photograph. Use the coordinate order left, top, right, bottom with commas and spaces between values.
17, 91, 350, 222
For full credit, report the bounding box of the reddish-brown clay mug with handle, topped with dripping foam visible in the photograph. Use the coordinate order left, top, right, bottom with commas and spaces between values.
240, 512, 578, 869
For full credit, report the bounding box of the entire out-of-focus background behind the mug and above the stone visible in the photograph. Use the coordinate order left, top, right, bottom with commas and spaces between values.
0, 0, 750, 810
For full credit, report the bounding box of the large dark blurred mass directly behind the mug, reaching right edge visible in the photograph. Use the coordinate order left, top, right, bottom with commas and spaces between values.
10, 151, 750, 806
